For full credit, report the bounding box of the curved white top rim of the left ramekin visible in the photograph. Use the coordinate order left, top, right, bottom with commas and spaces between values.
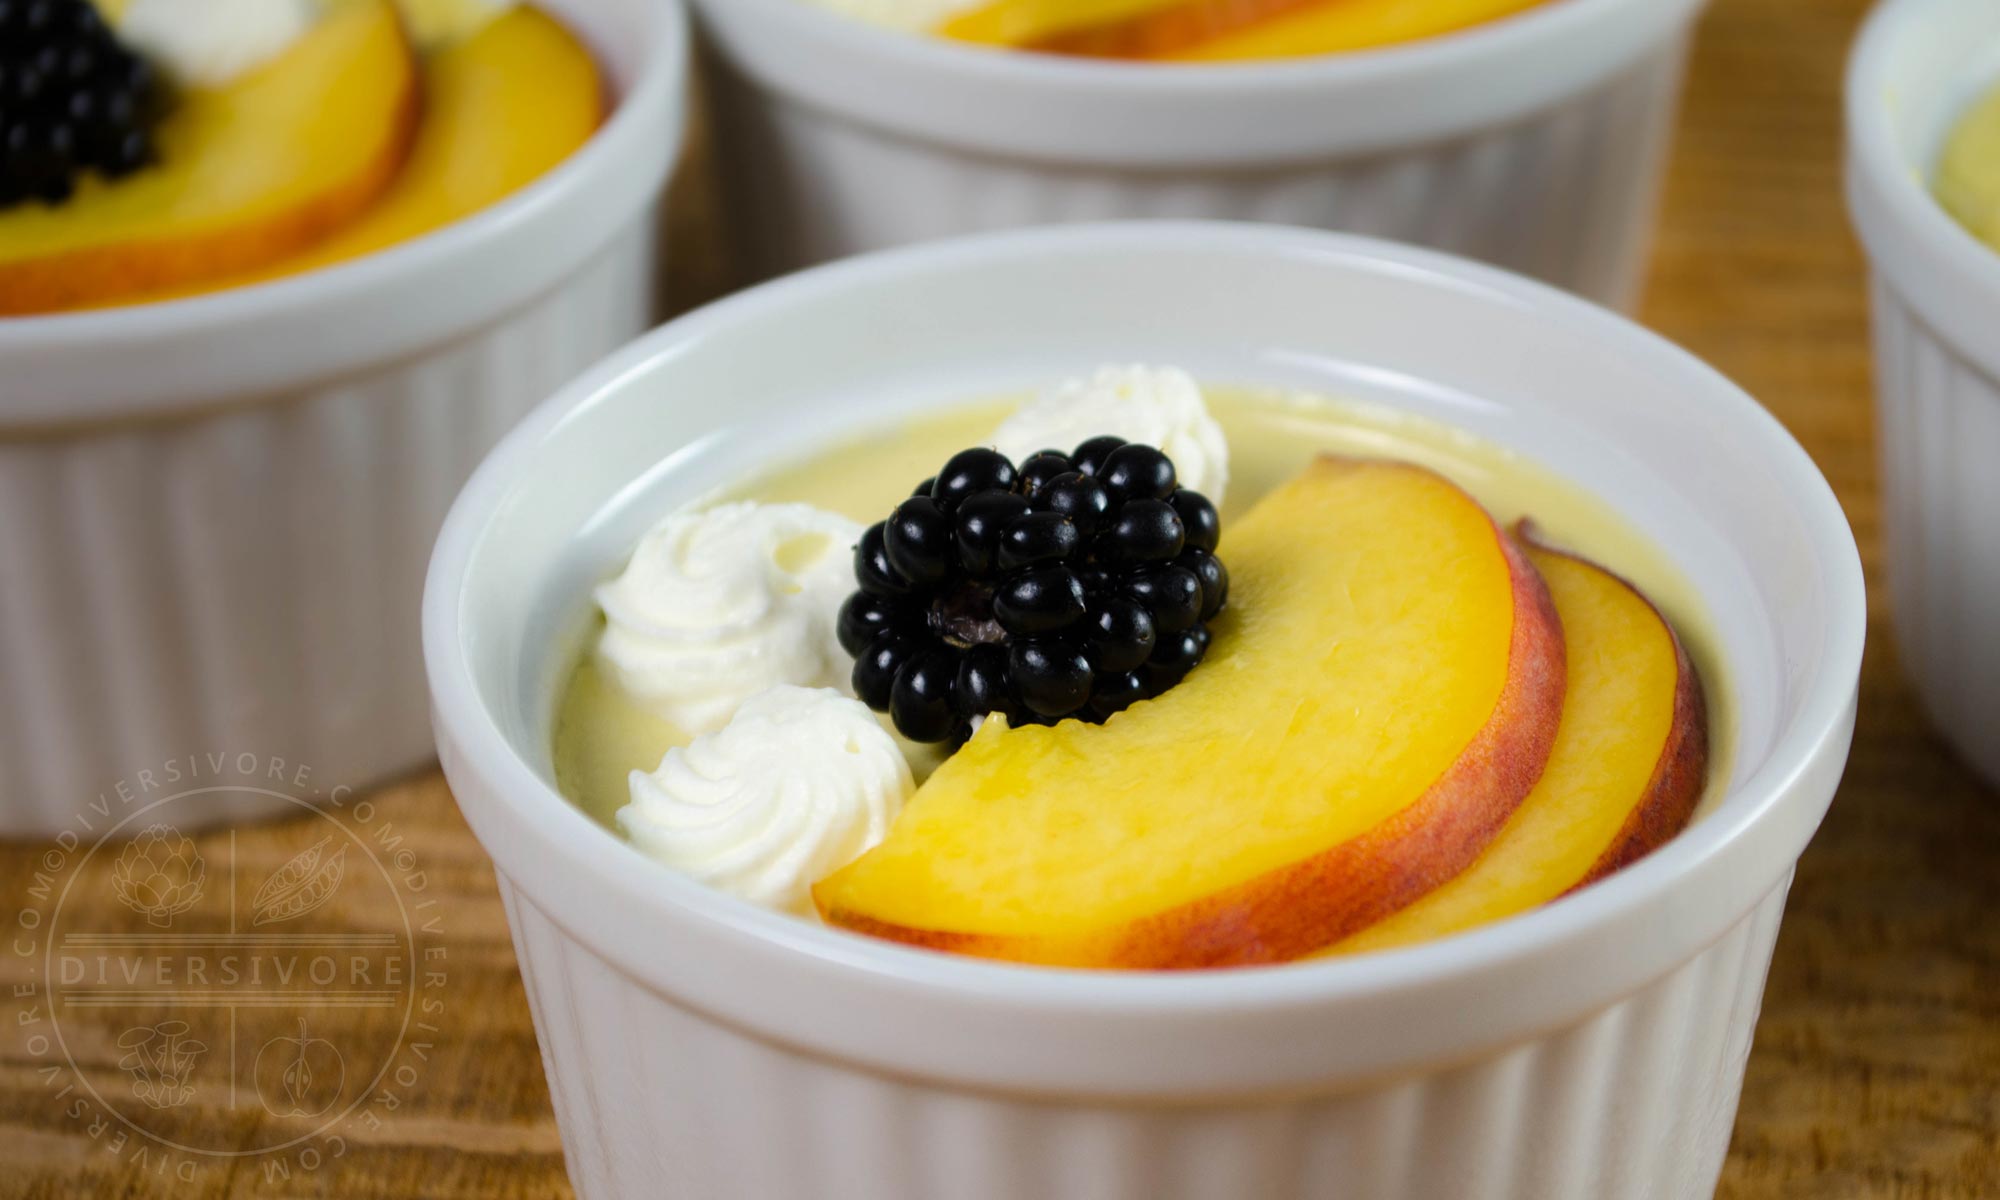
0, 0, 692, 354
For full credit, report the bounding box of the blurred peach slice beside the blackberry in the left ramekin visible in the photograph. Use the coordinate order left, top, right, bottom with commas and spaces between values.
0, 0, 418, 316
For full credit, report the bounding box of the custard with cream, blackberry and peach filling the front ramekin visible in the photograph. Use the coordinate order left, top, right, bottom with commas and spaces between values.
554, 368, 1730, 970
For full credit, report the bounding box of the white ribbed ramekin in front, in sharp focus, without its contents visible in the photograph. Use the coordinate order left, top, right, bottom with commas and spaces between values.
424, 224, 1864, 1200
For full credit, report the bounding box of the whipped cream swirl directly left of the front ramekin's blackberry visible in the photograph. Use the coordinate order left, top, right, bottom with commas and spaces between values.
596, 502, 862, 736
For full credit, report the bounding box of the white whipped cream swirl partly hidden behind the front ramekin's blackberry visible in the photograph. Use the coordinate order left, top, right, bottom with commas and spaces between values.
994, 366, 1230, 504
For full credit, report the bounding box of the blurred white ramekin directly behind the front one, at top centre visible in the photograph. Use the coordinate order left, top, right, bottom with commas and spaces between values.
694, 0, 1702, 306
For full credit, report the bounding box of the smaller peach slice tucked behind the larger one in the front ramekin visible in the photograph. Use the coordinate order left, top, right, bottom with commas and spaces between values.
1326, 544, 1708, 954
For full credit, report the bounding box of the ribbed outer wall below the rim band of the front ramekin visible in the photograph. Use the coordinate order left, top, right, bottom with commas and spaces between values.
502, 880, 1786, 1200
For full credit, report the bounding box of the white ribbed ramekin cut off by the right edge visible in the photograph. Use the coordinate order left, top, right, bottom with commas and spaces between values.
1848, 0, 2000, 784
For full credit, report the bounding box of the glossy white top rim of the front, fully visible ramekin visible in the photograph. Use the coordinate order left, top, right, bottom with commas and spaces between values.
424, 222, 1866, 1014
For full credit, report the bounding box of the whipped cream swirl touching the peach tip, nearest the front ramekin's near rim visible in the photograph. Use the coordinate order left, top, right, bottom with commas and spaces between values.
618, 686, 916, 914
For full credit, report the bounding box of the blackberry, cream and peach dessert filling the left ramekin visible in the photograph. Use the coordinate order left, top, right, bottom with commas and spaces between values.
0, 0, 606, 316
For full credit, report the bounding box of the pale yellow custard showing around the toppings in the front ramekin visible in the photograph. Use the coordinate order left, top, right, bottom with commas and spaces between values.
554, 388, 1734, 826
